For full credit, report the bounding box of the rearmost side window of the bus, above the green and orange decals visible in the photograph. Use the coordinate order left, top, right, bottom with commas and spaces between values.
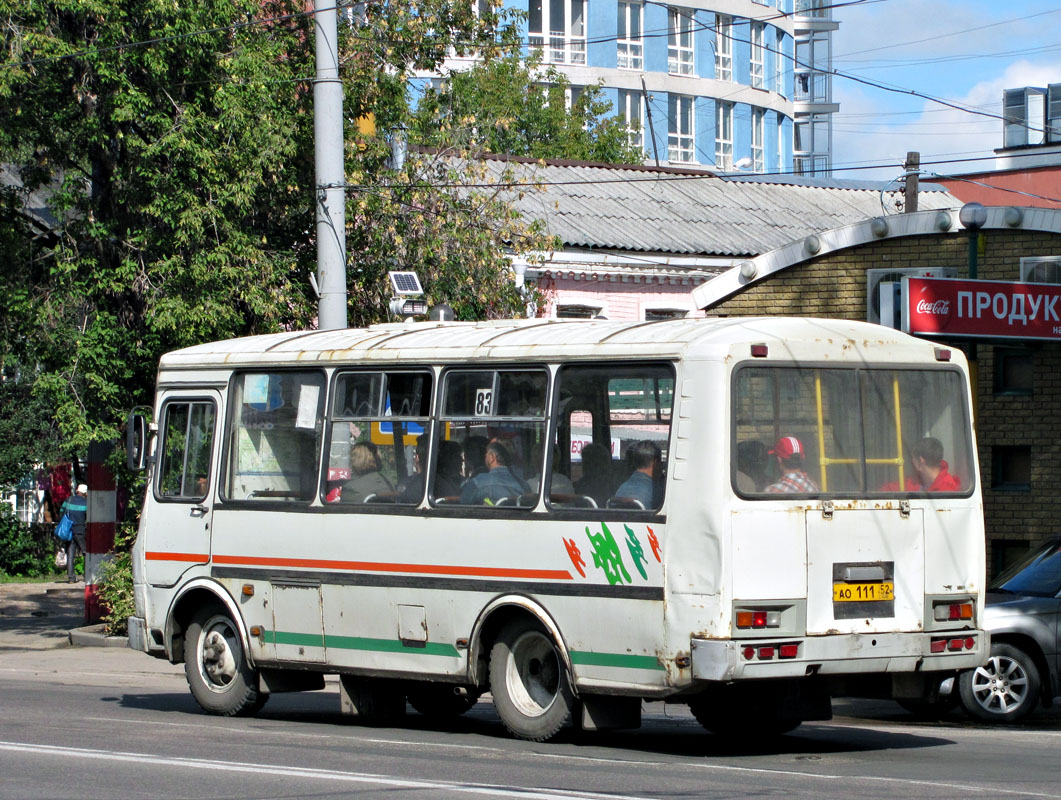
549, 364, 674, 511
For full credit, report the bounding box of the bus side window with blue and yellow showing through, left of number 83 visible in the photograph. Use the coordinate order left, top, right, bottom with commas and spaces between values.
324, 371, 433, 505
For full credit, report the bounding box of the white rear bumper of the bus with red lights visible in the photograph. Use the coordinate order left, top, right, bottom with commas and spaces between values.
691, 630, 989, 681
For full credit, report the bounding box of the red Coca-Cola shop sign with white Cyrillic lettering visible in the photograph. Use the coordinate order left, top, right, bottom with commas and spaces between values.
903, 278, 1061, 341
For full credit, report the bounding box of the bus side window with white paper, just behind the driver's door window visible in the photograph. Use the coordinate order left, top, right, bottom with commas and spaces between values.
226, 371, 325, 502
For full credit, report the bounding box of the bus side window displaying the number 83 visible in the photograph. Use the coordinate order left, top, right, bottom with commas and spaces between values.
439, 369, 549, 507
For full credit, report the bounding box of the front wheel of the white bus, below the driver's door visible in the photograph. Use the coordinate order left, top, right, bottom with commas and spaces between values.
185, 603, 268, 716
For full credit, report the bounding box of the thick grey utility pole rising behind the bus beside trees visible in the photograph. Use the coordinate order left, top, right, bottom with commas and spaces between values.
313, 0, 347, 331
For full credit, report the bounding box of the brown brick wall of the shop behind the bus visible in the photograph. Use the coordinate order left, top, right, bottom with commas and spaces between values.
708, 225, 1061, 571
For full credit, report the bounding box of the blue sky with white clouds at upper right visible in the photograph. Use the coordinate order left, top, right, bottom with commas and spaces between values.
833, 0, 1061, 180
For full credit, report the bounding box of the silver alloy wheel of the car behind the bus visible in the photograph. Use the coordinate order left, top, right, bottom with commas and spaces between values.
958, 642, 1040, 723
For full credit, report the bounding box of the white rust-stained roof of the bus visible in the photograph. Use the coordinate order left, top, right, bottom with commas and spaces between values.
159, 317, 960, 370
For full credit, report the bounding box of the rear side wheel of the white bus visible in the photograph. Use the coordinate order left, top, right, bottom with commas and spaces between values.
490, 620, 575, 742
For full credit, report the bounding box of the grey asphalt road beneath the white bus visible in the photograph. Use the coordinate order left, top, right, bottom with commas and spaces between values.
0, 648, 1061, 800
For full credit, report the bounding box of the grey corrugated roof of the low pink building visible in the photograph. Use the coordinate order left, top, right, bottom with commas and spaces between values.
486, 160, 961, 257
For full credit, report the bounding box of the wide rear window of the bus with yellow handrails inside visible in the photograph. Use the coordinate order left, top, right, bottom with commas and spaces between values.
732, 367, 975, 498
